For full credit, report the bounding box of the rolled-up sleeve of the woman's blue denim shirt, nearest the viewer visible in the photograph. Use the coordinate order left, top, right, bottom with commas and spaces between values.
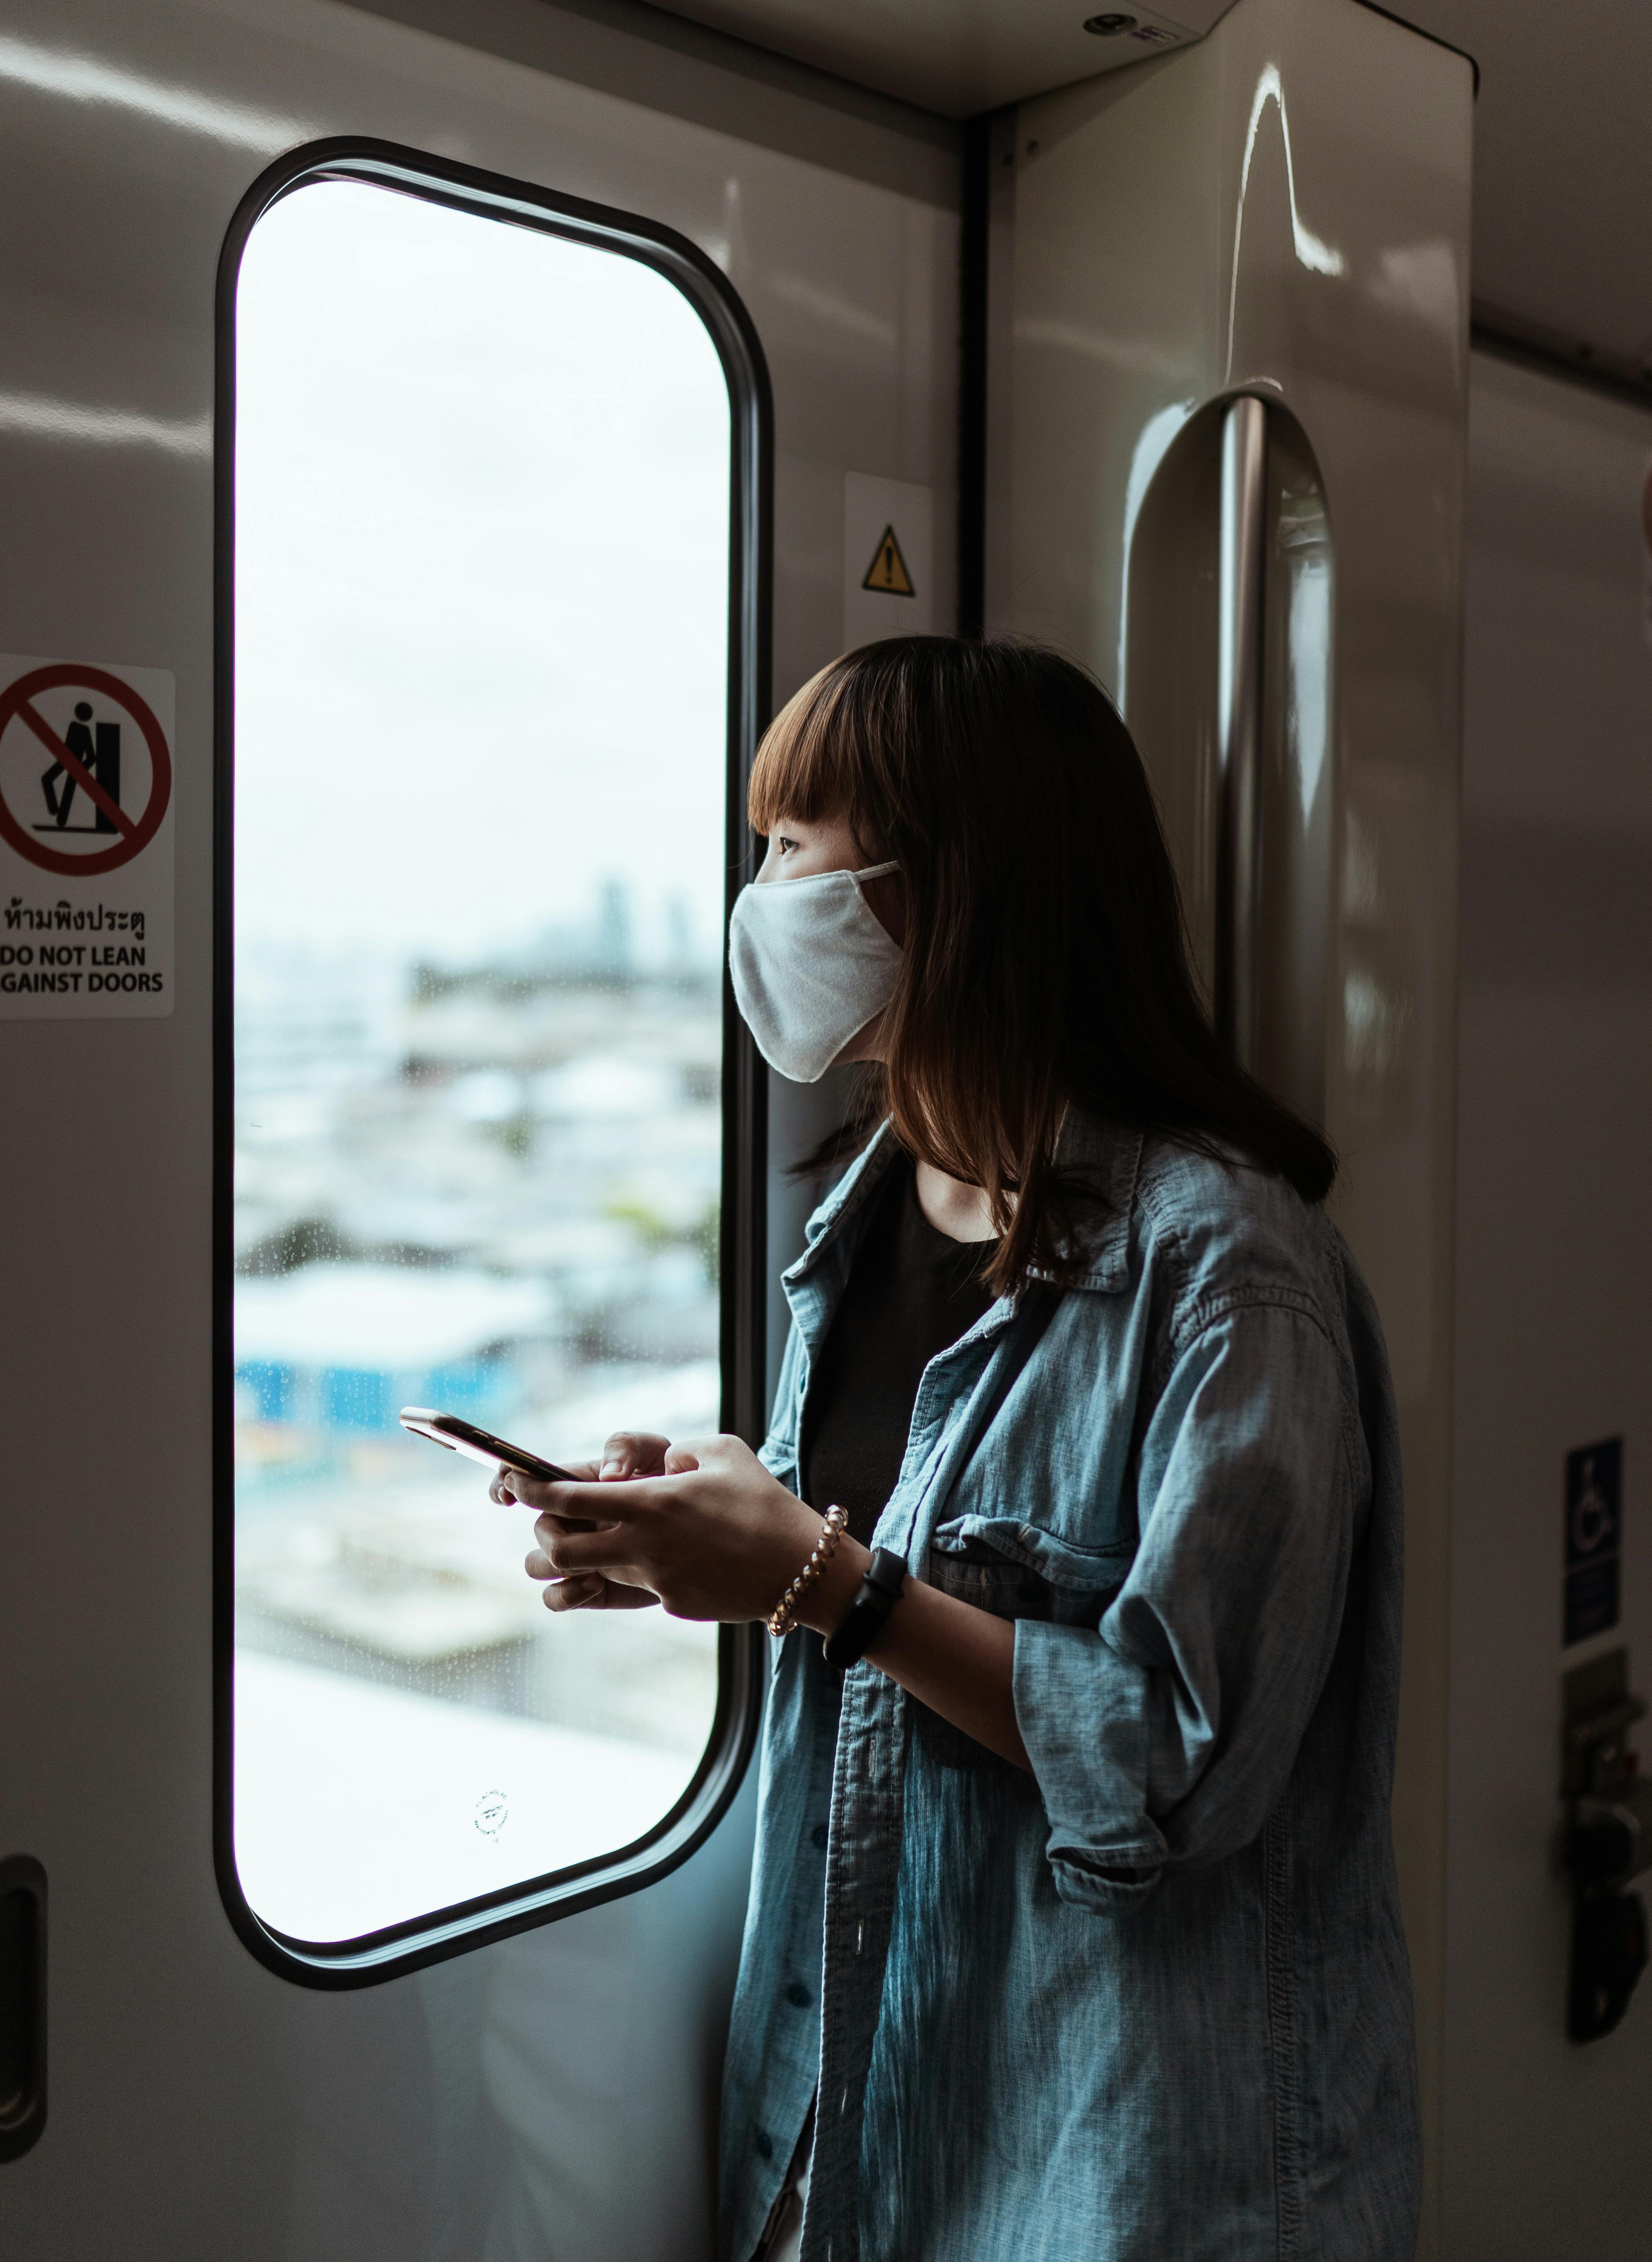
1014, 1301, 1364, 1914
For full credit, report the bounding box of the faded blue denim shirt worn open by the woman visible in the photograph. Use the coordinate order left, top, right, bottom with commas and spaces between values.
722, 1118, 1419, 2262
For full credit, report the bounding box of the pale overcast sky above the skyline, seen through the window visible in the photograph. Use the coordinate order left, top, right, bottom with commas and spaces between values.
235, 181, 729, 957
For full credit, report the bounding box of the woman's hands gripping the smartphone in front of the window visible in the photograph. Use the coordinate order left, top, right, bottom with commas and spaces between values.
509, 1437, 821, 1624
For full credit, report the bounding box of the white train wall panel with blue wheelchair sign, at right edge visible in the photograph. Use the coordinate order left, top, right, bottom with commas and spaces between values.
1446, 353, 1652, 2262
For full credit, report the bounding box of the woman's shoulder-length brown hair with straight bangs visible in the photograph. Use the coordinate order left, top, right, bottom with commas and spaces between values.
749, 636, 1335, 1291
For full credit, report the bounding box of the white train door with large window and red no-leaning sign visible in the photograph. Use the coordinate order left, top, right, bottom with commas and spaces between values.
0, 0, 959, 2262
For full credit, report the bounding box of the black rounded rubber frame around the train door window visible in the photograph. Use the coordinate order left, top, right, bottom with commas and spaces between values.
213, 136, 774, 1988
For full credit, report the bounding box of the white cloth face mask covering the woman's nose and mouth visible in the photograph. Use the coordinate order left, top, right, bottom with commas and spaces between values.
729, 864, 901, 1083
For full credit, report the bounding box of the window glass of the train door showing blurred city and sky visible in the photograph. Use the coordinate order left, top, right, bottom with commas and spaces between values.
235, 181, 731, 1941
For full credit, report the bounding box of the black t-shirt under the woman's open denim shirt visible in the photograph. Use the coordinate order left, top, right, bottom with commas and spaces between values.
799, 1156, 998, 1545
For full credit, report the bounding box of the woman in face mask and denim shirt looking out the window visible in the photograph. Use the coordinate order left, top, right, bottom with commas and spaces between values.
498, 638, 1419, 2262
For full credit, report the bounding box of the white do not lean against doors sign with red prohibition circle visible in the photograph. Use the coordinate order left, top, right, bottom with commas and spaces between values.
0, 654, 174, 1020
